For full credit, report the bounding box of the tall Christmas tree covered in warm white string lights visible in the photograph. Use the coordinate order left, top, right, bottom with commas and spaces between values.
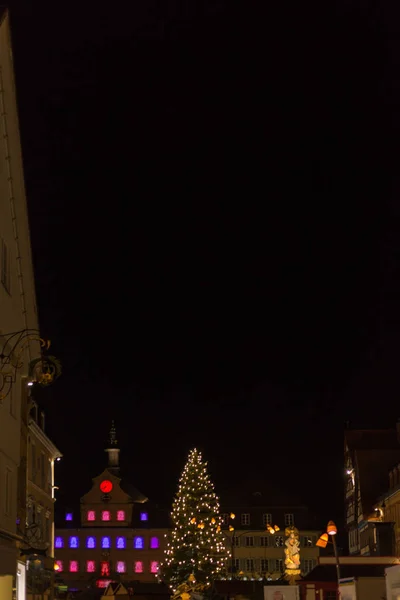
159, 449, 228, 591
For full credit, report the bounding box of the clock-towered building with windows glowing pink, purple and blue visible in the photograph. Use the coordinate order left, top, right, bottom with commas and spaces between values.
54, 424, 168, 590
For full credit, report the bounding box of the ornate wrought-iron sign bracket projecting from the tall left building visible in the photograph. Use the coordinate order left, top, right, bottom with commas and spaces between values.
0, 329, 62, 402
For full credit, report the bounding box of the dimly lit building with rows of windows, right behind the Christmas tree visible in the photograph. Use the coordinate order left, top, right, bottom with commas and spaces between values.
221, 492, 320, 580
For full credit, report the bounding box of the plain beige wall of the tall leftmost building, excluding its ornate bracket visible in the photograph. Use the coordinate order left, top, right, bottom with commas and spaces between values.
0, 11, 39, 600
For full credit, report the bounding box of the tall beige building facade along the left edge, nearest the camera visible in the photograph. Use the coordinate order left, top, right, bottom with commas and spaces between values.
0, 9, 45, 600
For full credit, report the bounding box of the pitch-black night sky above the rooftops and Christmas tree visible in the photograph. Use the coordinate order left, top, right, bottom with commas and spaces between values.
7, 0, 400, 518
